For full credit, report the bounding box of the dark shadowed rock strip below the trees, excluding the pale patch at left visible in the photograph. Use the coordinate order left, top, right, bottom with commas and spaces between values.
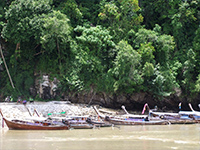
65, 92, 184, 111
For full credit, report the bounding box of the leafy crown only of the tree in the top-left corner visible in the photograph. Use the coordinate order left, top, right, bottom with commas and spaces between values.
2, 0, 51, 44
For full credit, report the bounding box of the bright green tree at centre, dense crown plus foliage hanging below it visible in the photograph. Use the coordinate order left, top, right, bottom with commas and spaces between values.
68, 26, 115, 90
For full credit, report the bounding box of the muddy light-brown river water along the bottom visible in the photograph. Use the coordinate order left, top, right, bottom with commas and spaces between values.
0, 124, 200, 150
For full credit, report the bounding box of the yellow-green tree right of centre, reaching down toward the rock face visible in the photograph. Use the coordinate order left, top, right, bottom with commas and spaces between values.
133, 25, 178, 97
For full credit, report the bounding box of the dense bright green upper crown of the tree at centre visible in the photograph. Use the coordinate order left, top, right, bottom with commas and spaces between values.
75, 26, 115, 69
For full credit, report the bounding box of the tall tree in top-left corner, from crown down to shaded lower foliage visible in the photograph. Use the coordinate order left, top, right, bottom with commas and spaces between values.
1, 0, 51, 95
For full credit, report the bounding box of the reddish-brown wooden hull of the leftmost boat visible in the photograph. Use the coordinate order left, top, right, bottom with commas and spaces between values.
3, 118, 69, 130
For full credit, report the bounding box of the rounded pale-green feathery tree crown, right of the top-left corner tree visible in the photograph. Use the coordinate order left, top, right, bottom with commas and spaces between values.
40, 11, 71, 53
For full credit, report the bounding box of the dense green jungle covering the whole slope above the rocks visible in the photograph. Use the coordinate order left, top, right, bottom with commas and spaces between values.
0, 0, 200, 101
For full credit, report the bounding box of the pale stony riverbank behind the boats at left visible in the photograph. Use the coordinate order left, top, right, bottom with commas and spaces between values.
0, 101, 103, 125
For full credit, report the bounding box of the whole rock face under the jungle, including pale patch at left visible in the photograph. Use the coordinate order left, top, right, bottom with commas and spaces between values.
10, 75, 200, 111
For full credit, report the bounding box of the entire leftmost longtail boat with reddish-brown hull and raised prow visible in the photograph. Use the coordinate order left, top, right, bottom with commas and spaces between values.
0, 110, 69, 130
